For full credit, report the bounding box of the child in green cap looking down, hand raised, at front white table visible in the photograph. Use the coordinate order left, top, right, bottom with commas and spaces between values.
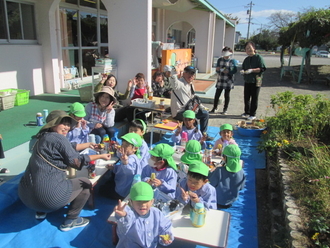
175, 160, 217, 209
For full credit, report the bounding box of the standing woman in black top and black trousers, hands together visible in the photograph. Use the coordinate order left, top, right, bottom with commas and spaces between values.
240, 41, 266, 120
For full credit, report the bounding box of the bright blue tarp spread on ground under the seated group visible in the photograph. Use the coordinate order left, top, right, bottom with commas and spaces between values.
0, 127, 265, 248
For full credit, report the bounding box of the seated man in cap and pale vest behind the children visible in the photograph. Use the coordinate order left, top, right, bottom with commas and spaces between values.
170, 66, 209, 136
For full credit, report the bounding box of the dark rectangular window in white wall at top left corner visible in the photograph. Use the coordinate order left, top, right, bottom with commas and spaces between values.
0, 1, 37, 43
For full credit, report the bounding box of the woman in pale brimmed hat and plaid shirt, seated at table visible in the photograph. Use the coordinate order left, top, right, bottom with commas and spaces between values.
85, 86, 116, 143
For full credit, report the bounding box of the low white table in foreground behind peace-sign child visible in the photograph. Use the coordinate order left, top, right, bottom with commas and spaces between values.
108, 205, 230, 248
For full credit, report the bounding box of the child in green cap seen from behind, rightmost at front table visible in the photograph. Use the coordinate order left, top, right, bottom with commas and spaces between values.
210, 144, 245, 208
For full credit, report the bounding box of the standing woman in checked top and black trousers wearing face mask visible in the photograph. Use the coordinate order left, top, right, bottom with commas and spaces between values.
209, 47, 237, 115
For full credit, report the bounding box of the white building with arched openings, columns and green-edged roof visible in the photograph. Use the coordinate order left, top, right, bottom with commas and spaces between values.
0, 0, 235, 95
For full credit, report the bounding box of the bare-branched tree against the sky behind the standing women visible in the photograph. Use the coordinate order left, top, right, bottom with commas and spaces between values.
267, 11, 297, 32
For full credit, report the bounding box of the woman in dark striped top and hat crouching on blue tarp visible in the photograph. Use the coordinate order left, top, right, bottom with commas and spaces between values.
18, 110, 110, 231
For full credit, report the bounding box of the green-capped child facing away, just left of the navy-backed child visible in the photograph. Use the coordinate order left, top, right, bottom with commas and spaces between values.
178, 140, 203, 182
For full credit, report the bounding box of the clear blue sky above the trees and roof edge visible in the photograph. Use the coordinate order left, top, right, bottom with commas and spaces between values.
208, 0, 330, 38
